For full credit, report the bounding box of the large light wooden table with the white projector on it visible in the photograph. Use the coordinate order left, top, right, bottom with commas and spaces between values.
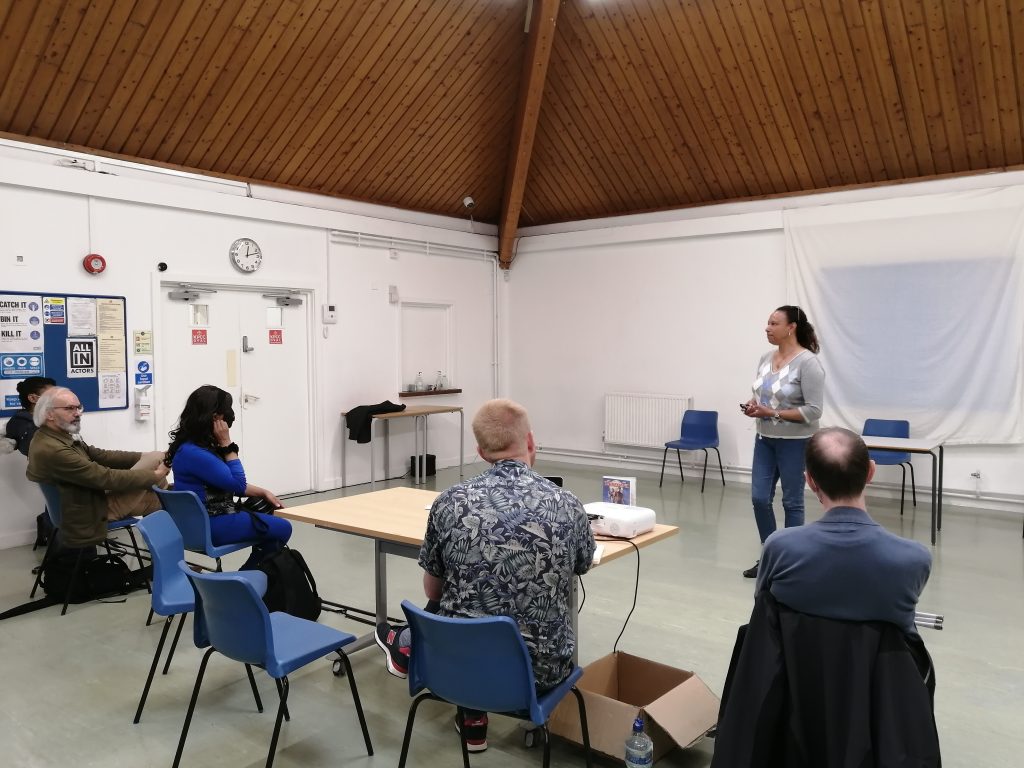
275, 487, 679, 651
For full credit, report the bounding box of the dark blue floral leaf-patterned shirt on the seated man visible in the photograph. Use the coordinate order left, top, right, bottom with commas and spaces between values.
420, 460, 594, 689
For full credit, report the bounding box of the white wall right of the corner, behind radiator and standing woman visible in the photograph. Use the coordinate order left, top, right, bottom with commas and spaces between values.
512, 177, 1024, 511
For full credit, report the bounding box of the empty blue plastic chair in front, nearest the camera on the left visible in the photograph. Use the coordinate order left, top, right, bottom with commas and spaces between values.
174, 560, 374, 768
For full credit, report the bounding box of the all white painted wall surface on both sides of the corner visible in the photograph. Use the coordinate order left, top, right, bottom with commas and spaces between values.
0, 141, 1024, 548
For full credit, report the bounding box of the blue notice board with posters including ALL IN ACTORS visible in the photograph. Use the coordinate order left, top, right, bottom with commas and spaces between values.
0, 291, 128, 417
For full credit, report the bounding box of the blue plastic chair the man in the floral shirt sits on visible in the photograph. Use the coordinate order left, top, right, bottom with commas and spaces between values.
398, 600, 591, 768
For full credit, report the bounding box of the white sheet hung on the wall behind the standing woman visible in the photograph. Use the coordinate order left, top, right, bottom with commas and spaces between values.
784, 187, 1024, 444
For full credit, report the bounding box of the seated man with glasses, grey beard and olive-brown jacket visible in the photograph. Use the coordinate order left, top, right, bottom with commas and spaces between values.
25, 387, 168, 548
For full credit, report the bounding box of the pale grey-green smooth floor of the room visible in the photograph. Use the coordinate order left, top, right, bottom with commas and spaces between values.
0, 463, 1024, 768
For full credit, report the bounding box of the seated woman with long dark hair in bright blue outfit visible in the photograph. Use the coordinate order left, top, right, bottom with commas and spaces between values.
165, 384, 292, 568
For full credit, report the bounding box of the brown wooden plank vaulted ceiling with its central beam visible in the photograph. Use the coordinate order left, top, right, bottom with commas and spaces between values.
0, 0, 1024, 263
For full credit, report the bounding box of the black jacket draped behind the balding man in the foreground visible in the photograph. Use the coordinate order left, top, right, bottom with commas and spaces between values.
712, 592, 941, 768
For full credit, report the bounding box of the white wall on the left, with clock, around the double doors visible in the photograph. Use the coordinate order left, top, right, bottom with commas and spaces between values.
0, 142, 496, 548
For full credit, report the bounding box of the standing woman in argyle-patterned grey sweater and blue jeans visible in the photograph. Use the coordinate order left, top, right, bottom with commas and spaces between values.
739, 304, 825, 579
